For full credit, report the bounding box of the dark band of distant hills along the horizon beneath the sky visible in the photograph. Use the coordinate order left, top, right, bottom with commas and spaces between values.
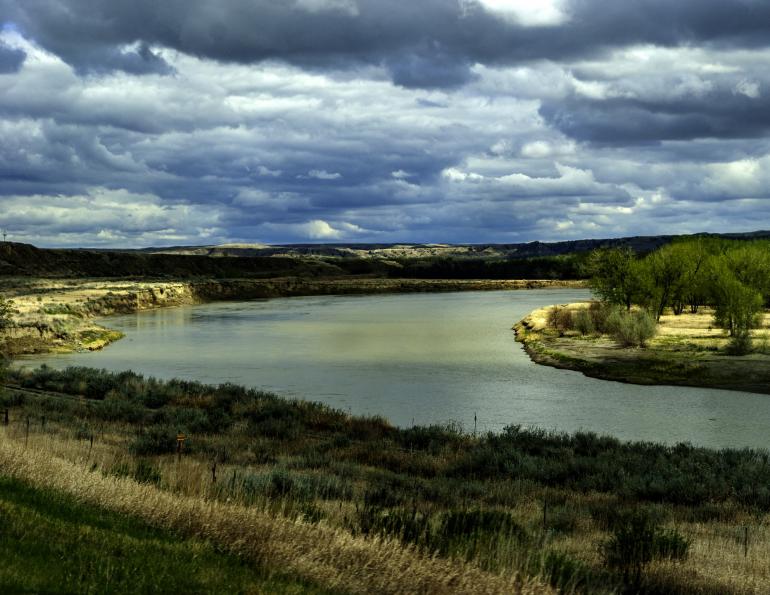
0, 231, 770, 279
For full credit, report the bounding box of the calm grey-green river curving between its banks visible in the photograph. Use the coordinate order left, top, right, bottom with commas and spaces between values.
16, 289, 770, 448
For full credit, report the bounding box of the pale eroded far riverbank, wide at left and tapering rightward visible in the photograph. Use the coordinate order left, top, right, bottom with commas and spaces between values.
3, 277, 582, 355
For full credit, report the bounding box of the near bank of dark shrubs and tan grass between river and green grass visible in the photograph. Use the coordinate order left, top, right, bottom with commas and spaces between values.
0, 367, 770, 594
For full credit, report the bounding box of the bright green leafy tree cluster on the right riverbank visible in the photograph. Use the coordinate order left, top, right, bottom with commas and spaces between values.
587, 238, 770, 352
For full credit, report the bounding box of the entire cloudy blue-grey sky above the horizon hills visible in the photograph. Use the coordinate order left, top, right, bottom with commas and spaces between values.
0, 0, 770, 247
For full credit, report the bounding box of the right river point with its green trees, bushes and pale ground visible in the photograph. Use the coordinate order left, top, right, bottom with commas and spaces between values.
515, 238, 770, 393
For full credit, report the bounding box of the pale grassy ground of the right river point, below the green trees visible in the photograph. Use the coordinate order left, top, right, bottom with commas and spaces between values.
514, 303, 770, 393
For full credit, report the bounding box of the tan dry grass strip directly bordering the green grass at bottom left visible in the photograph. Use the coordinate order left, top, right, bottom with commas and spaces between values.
0, 432, 553, 594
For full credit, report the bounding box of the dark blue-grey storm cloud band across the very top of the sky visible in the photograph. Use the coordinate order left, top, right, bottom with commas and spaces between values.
1, 0, 770, 87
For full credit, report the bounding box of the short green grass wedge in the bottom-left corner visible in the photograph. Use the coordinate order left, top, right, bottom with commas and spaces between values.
0, 476, 336, 594
